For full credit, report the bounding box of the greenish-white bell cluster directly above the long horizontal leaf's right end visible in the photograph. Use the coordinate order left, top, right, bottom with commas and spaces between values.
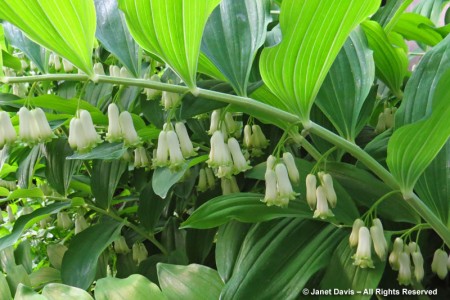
306, 172, 337, 219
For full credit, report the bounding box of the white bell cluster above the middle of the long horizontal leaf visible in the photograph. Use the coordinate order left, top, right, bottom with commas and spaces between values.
262, 153, 299, 207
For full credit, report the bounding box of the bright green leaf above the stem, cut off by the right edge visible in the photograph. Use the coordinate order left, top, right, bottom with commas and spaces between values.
386, 67, 450, 196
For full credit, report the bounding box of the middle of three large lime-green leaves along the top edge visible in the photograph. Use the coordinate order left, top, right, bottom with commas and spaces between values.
119, 0, 220, 89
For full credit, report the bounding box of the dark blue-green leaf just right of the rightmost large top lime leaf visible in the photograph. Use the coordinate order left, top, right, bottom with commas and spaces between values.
316, 28, 375, 140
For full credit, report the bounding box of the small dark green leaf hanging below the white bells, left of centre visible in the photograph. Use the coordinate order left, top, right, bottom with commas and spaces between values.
91, 159, 128, 209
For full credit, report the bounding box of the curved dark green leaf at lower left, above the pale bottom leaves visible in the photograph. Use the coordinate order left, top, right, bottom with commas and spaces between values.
61, 220, 123, 290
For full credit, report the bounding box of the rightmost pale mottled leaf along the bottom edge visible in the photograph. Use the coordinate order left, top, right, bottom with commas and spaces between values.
157, 263, 223, 300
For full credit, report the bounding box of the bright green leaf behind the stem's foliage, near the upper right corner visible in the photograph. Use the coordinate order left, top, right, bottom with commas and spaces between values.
362, 21, 408, 98
